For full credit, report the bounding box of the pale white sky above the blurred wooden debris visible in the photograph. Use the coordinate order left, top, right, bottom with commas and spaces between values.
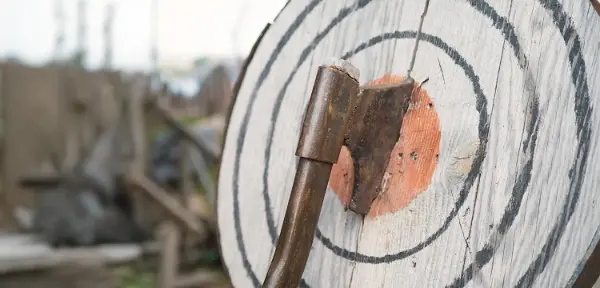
0, 0, 286, 71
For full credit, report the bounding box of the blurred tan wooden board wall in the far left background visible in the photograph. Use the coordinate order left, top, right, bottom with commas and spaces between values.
0, 63, 123, 229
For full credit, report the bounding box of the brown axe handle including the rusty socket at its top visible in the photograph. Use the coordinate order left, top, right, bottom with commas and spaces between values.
263, 61, 358, 287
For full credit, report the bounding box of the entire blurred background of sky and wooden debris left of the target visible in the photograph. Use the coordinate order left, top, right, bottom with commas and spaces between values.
0, 0, 286, 288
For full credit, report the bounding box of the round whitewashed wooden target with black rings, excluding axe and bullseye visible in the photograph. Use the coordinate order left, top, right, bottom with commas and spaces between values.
218, 0, 600, 287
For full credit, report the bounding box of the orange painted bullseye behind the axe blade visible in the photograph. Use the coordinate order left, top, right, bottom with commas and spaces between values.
329, 74, 441, 218
